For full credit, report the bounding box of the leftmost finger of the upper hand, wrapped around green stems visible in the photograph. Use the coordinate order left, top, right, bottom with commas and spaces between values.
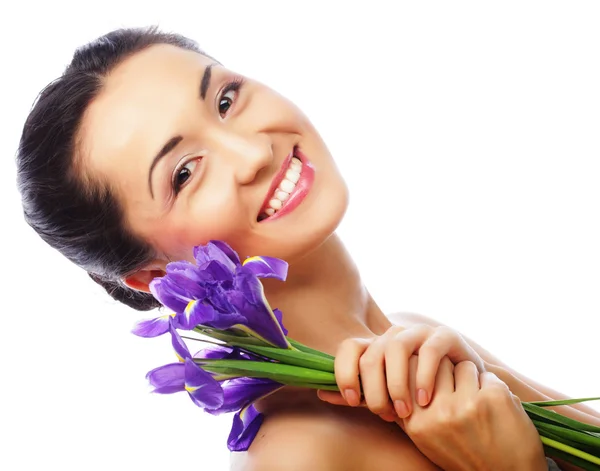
334, 338, 372, 407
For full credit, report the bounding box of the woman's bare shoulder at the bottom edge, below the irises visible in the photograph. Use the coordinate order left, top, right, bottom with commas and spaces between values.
230, 410, 438, 471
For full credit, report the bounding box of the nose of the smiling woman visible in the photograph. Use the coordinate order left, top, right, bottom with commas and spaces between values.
219, 134, 273, 185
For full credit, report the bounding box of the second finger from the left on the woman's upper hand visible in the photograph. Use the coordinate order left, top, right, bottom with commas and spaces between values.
358, 336, 394, 415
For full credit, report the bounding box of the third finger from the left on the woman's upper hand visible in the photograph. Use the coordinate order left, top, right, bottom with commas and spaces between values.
385, 326, 430, 418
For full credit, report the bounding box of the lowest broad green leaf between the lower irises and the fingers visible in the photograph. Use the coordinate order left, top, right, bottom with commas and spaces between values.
194, 358, 336, 384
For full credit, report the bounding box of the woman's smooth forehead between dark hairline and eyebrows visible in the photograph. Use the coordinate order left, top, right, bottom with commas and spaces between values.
79, 44, 214, 183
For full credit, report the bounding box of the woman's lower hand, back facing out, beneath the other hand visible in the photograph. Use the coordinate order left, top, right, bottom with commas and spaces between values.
398, 357, 548, 471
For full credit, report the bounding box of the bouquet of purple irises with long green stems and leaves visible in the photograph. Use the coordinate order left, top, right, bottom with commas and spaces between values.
133, 241, 600, 470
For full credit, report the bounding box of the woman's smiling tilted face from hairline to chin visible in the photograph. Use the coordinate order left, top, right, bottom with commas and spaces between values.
80, 45, 347, 276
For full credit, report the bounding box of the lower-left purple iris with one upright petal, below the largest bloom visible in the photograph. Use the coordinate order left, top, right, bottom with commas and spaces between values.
146, 326, 224, 409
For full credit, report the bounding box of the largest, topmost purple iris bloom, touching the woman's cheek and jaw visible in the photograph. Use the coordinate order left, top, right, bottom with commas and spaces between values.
141, 241, 290, 348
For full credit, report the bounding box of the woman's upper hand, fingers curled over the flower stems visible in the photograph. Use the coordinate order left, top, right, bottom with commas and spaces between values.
319, 324, 485, 421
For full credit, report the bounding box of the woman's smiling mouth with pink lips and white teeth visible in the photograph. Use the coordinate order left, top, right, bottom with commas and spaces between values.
257, 147, 313, 222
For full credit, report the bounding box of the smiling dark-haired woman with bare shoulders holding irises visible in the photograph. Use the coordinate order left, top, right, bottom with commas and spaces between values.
18, 30, 600, 470
